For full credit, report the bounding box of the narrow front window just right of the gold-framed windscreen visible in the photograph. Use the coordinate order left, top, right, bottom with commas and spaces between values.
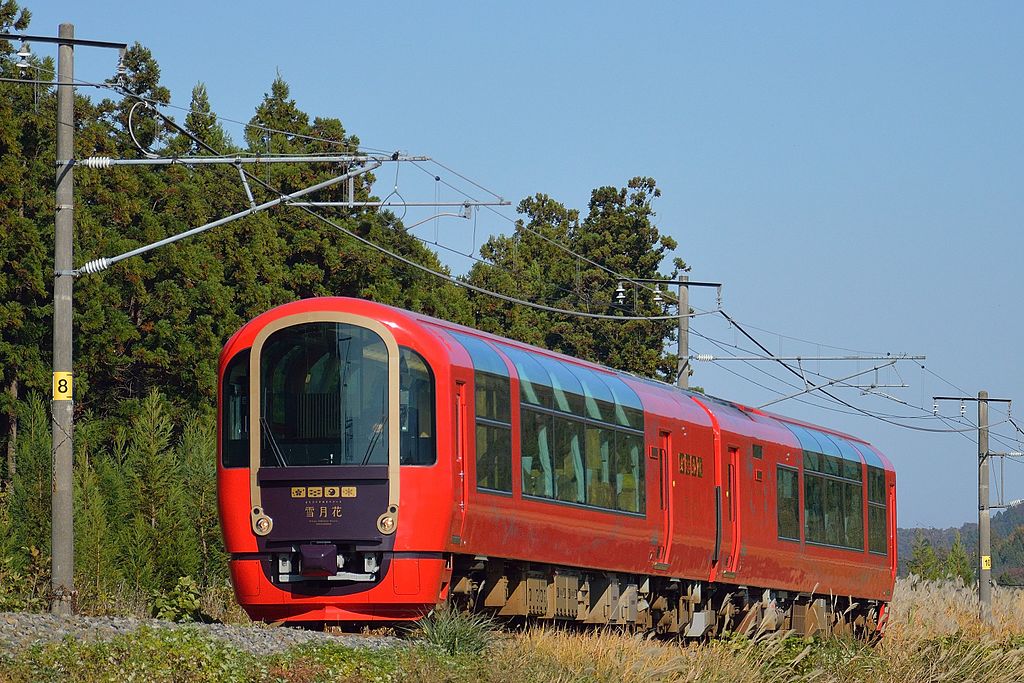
398, 346, 437, 465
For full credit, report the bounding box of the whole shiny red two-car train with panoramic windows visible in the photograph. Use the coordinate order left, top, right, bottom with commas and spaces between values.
217, 298, 896, 637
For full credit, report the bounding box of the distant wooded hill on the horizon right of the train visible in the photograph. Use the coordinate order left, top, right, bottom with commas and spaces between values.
896, 503, 1024, 586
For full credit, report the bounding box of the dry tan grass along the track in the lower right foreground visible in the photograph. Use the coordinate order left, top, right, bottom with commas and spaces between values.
480, 581, 1024, 683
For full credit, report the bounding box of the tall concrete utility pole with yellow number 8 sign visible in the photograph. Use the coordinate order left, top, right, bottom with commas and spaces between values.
50, 24, 75, 614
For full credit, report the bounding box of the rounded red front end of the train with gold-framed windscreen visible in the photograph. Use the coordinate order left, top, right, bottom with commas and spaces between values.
217, 298, 453, 622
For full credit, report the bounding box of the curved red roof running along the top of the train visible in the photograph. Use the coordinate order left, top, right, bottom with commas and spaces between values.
221, 297, 893, 470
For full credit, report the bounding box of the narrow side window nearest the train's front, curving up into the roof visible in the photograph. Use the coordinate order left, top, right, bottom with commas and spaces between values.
447, 330, 512, 493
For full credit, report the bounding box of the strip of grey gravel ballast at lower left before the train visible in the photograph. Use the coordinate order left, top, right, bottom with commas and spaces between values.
0, 612, 401, 654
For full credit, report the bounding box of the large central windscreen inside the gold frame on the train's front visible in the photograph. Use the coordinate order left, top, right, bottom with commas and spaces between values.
260, 323, 397, 467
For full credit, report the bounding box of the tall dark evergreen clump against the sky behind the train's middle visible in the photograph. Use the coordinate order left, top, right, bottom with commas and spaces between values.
468, 177, 685, 380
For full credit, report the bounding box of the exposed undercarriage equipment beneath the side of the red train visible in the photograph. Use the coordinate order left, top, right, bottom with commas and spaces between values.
449, 556, 885, 640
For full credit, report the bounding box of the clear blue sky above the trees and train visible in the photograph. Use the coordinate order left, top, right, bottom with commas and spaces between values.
22, 0, 1024, 525
